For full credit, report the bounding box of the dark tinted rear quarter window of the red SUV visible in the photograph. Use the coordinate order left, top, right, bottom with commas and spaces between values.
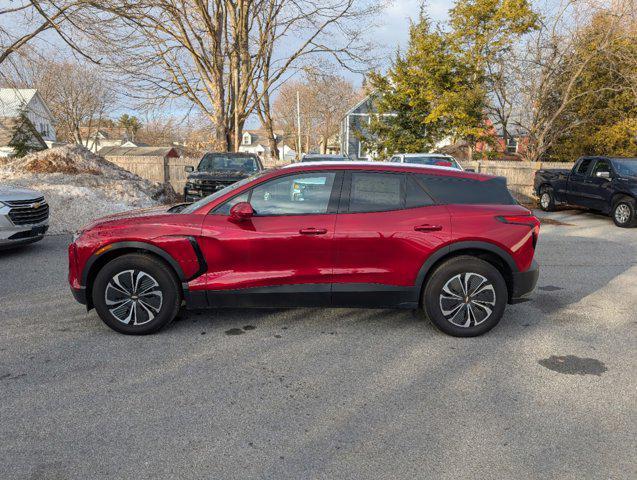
414, 173, 517, 205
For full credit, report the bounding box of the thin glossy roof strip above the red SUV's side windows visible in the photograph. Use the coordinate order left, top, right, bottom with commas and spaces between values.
280, 160, 494, 180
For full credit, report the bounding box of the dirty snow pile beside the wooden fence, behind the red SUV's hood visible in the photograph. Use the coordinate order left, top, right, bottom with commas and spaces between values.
0, 145, 177, 233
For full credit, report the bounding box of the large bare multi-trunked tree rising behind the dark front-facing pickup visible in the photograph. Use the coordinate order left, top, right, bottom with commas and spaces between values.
91, 0, 378, 150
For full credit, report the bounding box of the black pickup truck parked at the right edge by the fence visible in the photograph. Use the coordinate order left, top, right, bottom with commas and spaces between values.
534, 157, 637, 227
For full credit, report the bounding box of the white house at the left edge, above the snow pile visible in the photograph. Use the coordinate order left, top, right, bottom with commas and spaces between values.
0, 88, 56, 146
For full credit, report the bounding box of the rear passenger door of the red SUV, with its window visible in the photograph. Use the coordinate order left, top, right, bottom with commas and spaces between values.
332, 170, 451, 306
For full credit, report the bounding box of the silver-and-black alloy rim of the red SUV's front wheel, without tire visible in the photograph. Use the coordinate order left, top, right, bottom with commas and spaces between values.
104, 270, 164, 325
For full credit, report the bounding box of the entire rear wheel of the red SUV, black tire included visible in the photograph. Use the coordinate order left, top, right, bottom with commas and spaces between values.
422, 255, 508, 337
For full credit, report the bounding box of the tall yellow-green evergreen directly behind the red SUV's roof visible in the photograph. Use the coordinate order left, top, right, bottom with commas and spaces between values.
361, 0, 537, 156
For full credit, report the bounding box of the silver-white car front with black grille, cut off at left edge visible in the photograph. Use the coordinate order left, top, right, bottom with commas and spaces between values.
0, 185, 49, 248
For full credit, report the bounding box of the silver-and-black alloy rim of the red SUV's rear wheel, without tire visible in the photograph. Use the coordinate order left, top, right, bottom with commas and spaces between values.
439, 272, 496, 328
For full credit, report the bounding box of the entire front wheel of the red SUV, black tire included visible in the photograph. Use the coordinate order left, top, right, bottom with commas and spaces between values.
92, 253, 181, 335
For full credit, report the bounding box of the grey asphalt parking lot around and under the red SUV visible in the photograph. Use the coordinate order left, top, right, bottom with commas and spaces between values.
0, 210, 637, 479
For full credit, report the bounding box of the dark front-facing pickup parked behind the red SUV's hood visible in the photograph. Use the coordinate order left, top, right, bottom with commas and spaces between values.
184, 152, 263, 202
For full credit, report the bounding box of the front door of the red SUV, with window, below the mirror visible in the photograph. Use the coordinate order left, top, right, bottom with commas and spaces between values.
201, 171, 342, 306
